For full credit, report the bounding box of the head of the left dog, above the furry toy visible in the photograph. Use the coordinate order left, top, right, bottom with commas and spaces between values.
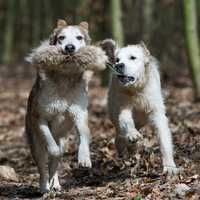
50, 19, 91, 54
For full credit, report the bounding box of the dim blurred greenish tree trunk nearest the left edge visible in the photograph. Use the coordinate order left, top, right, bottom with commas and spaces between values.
2, 0, 16, 63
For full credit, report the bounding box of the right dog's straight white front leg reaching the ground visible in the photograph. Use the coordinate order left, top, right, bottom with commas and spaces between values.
151, 113, 178, 174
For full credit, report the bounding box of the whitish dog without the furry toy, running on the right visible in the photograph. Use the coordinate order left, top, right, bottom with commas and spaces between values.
105, 40, 177, 174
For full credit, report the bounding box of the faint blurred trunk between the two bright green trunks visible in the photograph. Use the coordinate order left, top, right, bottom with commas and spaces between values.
143, 0, 155, 42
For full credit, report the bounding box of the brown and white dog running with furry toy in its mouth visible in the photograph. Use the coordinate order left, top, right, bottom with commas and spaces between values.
26, 20, 107, 193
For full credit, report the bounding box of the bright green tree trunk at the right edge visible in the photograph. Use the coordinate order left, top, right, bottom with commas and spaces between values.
184, 0, 200, 100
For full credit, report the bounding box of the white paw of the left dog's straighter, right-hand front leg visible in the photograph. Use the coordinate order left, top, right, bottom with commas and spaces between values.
78, 148, 92, 168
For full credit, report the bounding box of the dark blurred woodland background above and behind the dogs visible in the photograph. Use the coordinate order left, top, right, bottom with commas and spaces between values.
0, 0, 200, 99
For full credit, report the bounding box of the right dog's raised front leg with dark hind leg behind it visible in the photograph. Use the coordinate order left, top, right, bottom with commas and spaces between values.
115, 108, 142, 156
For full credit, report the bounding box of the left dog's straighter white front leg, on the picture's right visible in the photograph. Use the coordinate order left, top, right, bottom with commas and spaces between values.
71, 105, 92, 168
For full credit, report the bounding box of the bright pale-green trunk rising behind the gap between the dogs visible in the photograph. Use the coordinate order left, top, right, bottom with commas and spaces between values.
110, 0, 124, 46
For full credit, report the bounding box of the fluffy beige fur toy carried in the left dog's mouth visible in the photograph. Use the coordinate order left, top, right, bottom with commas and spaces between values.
27, 41, 107, 74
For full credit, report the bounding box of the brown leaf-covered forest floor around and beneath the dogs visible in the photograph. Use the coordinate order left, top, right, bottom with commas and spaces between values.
0, 65, 200, 200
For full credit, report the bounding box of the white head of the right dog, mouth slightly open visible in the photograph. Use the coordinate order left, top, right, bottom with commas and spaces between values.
115, 42, 150, 87
